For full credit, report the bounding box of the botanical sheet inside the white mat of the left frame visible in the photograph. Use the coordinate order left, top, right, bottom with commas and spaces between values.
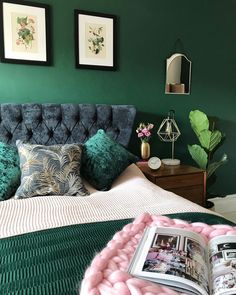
12, 13, 38, 53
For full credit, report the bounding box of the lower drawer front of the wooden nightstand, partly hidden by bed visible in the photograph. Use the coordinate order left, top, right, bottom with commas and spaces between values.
170, 185, 205, 206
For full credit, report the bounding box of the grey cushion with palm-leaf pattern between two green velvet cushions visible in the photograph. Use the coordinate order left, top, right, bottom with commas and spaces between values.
15, 140, 89, 199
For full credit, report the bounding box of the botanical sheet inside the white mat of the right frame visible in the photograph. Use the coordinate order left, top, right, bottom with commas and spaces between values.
85, 23, 106, 58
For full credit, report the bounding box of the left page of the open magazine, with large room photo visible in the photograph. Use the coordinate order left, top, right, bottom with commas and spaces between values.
128, 227, 209, 295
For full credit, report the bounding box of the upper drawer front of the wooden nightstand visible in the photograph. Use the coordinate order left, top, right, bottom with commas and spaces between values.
155, 173, 204, 190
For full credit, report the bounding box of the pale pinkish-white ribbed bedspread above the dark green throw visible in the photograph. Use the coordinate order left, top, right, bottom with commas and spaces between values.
0, 164, 218, 238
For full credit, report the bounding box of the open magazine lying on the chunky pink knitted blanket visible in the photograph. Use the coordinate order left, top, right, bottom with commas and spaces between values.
128, 227, 236, 295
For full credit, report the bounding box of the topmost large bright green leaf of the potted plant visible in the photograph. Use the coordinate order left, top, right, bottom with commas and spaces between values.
189, 110, 209, 137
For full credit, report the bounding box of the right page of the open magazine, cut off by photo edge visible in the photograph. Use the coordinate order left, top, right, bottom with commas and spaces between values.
209, 235, 236, 295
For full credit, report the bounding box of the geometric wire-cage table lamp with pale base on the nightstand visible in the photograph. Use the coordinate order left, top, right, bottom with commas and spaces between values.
157, 110, 181, 165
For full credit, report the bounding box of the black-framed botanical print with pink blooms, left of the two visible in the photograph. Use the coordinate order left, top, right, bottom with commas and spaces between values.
0, 0, 51, 65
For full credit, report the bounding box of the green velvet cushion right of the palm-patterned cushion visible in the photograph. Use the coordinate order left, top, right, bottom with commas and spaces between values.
81, 129, 138, 191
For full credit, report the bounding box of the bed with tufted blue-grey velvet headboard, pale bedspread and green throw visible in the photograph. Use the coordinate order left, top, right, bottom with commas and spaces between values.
0, 104, 232, 295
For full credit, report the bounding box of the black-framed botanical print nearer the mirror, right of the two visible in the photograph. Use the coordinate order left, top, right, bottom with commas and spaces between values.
75, 10, 116, 70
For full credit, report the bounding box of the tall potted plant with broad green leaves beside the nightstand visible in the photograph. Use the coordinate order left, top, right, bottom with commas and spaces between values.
188, 110, 228, 208
